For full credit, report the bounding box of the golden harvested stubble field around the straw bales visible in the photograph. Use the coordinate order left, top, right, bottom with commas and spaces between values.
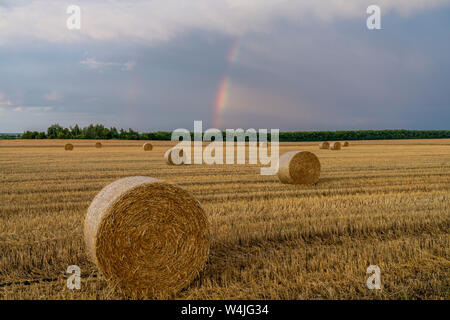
0, 139, 450, 299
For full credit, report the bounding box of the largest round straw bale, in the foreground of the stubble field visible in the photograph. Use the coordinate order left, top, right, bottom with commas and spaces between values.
84, 177, 210, 298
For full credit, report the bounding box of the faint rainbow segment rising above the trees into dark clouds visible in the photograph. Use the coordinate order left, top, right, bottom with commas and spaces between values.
213, 38, 240, 129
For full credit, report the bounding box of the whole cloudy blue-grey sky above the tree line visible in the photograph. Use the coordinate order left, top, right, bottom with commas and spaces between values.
0, 0, 450, 132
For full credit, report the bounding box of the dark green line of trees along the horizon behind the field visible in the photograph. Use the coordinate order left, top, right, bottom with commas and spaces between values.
13, 124, 450, 142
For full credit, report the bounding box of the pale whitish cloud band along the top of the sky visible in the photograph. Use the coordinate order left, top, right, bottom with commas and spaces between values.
0, 0, 449, 45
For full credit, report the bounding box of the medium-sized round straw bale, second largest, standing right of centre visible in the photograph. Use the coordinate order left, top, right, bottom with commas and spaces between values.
278, 151, 321, 184
